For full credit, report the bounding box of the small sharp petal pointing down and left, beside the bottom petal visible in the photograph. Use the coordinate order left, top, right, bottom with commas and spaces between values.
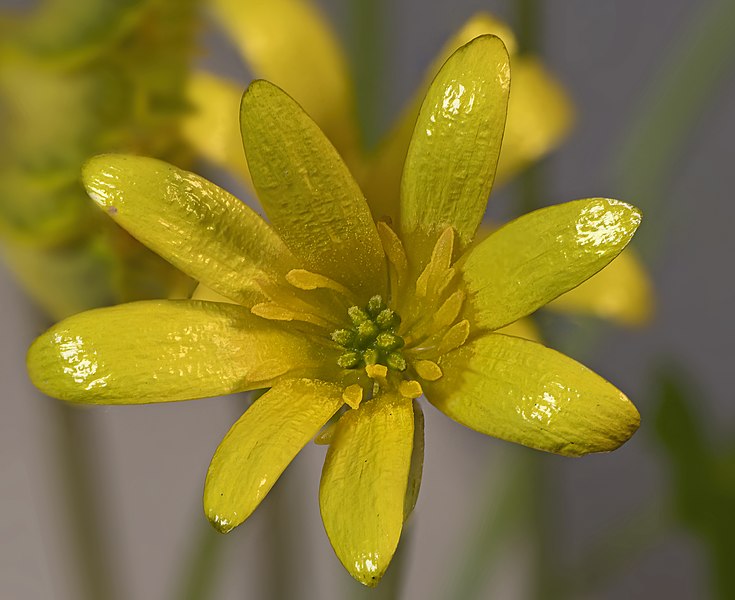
204, 379, 343, 533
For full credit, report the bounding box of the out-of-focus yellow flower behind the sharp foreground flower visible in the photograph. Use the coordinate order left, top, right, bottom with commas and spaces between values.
184, 0, 653, 328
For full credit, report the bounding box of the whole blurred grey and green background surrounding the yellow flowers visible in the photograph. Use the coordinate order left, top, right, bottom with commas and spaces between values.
0, 0, 735, 600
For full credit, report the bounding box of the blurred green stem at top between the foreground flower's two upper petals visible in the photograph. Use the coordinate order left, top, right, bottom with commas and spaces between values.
350, 0, 387, 150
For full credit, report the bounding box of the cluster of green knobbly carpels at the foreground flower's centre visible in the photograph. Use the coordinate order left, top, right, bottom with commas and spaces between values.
331, 296, 406, 371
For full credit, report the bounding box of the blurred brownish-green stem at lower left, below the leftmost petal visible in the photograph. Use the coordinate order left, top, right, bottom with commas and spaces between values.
53, 399, 119, 600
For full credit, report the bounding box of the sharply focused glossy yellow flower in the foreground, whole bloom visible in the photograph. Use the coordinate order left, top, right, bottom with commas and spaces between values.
28, 36, 640, 585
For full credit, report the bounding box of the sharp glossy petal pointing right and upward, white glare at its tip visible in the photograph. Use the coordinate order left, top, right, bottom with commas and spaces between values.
460, 198, 641, 329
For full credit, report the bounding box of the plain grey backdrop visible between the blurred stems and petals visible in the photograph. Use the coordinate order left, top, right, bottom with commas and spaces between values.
0, 0, 735, 600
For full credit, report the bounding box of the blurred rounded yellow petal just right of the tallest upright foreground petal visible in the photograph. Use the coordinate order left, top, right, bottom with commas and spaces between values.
495, 57, 573, 183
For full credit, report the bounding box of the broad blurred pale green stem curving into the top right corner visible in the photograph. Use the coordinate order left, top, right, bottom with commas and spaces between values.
615, 0, 735, 259
